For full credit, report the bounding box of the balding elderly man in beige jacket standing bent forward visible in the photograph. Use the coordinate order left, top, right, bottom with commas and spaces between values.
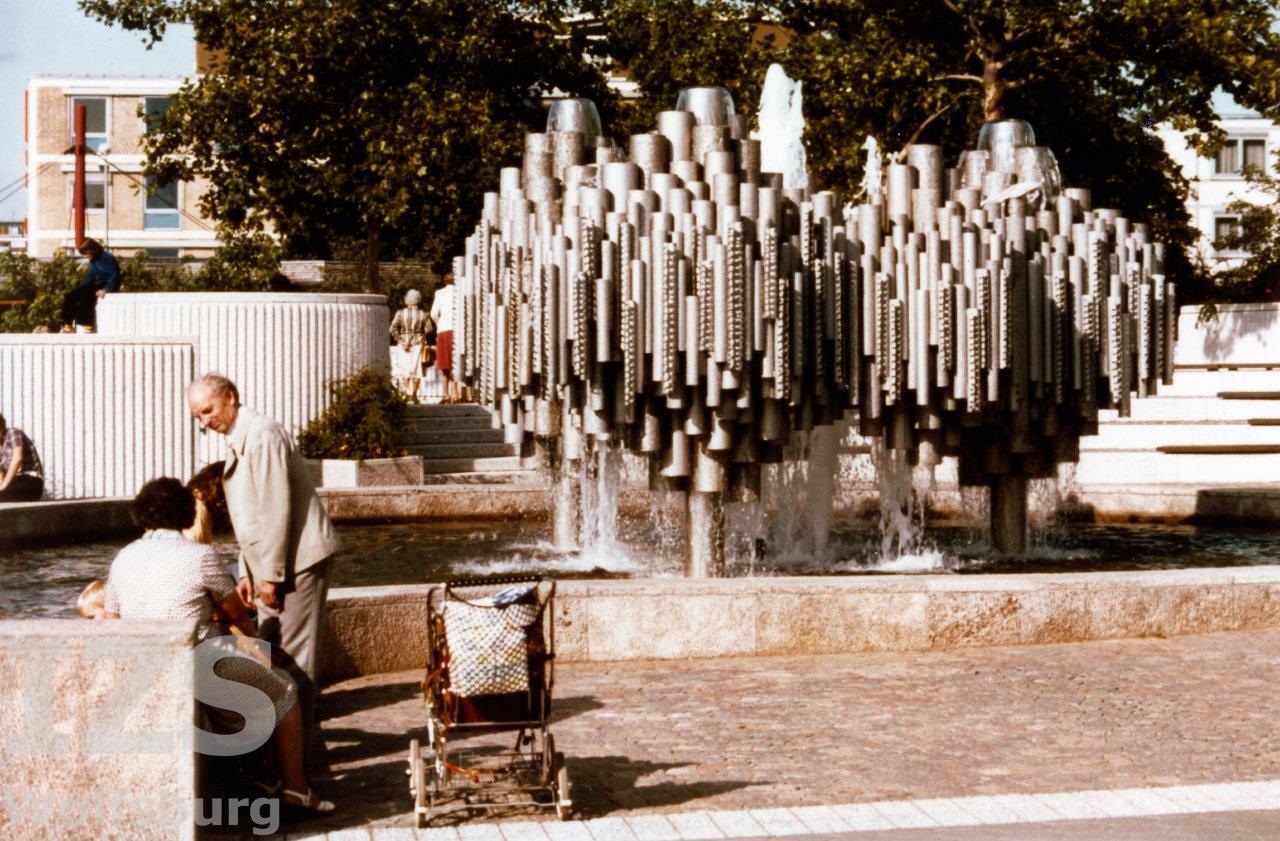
187, 374, 338, 752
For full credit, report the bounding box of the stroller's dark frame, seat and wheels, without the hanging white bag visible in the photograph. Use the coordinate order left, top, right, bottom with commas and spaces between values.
407, 576, 573, 828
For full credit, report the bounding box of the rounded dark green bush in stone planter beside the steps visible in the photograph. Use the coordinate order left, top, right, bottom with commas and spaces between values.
298, 367, 408, 458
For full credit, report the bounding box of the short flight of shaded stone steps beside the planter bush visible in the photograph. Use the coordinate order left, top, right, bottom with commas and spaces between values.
397, 403, 536, 484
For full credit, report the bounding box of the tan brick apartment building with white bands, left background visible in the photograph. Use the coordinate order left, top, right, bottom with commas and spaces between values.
26, 77, 218, 260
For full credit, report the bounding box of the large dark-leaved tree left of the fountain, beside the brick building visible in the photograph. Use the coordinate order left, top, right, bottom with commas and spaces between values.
79, 0, 612, 291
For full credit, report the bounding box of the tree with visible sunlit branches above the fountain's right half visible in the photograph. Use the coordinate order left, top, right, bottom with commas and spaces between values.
763, 0, 1280, 291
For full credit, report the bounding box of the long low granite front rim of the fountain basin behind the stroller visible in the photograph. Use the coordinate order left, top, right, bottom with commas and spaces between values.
321, 566, 1280, 681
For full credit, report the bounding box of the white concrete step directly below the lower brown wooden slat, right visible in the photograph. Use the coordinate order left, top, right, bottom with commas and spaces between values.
1075, 451, 1280, 485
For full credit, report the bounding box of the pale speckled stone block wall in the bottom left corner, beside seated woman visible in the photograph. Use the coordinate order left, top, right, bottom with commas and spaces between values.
0, 620, 195, 841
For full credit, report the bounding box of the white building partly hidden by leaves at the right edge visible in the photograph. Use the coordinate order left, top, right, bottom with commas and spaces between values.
1158, 108, 1280, 269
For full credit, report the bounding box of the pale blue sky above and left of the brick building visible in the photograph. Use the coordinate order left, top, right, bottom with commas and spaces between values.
0, 0, 196, 219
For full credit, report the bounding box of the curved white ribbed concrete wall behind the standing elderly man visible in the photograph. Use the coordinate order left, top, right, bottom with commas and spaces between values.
97, 292, 389, 465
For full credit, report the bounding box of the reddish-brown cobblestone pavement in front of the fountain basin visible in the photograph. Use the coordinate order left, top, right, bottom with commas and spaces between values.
292, 630, 1280, 832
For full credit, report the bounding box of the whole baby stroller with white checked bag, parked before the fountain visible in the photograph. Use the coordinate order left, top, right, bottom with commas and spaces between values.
408, 577, 572, 828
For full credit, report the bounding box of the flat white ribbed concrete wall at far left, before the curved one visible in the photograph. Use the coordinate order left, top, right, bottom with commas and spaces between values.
0, 335, 196, 499
